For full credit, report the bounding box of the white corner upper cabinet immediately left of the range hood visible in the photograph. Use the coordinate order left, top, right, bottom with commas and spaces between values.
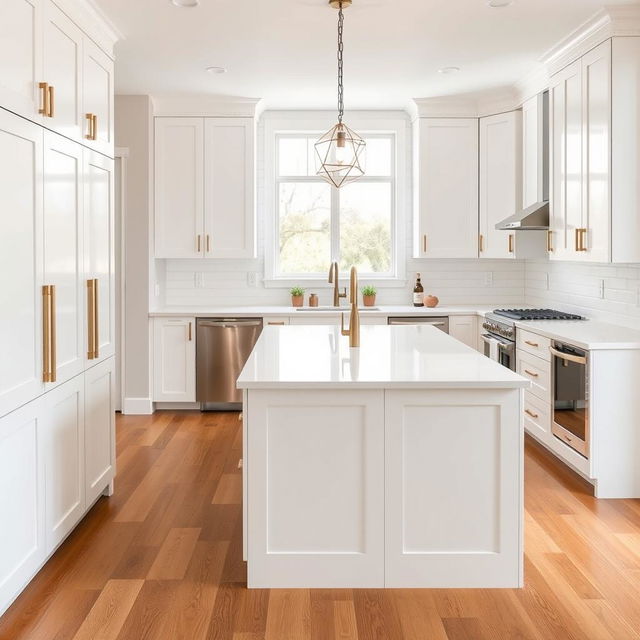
479, 111, 522, 258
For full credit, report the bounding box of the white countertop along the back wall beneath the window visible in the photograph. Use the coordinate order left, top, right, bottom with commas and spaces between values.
149, 303, 495, 318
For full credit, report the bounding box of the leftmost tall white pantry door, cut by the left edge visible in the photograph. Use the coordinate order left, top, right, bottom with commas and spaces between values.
0, 109, 43, 415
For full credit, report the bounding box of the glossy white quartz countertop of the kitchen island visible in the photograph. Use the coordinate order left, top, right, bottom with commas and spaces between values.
237, 325, 530, 389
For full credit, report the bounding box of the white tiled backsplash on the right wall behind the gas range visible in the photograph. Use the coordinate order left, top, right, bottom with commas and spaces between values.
525, 261, 640, 329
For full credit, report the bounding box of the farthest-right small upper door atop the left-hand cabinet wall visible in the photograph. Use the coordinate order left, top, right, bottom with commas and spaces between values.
82, 38, 114, 157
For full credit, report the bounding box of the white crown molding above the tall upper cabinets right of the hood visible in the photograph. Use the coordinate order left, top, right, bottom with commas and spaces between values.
540, 5, 640, 75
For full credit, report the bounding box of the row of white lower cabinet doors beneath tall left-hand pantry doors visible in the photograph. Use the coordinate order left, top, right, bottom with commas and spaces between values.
0, 357, 115, 615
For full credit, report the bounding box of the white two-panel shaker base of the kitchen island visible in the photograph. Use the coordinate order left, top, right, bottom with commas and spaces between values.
244, 388, 523, 588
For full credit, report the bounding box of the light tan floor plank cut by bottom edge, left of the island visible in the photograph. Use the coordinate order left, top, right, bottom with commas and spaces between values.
73, 580, 144, 640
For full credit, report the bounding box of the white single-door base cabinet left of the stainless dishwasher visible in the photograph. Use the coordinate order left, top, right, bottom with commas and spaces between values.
153, 318, 196, 402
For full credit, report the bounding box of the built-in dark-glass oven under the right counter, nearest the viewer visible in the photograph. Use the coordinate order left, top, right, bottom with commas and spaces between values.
549, 341, 589, 458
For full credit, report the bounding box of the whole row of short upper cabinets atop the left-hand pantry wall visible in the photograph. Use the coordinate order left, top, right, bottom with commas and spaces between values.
0, 0, 113, 156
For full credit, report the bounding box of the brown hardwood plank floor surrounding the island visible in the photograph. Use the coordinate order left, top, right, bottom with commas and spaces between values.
0, 412, 640, 640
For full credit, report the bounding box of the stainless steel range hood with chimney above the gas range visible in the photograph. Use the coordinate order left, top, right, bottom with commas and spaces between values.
496, 92, 549, 231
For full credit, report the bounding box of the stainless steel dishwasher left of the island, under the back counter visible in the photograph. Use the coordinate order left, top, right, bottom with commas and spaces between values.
196, 318, 262, 411
